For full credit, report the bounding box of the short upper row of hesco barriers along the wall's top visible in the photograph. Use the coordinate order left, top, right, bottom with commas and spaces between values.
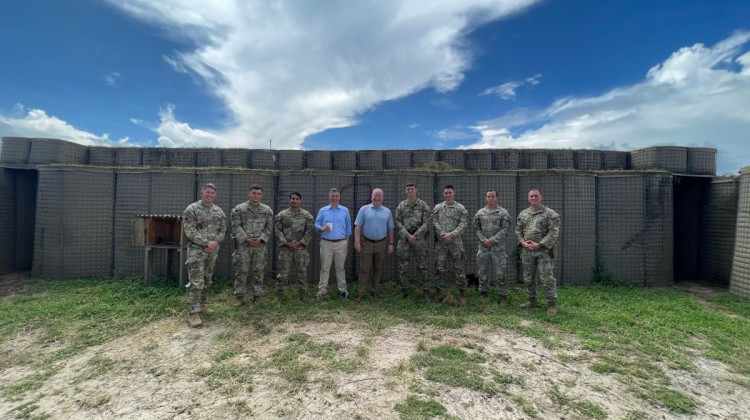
0, 137, 716, 175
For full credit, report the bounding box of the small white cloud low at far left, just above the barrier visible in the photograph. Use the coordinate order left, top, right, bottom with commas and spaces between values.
0, 104, 128, 146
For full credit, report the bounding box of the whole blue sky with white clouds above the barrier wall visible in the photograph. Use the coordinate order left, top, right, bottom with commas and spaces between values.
0, 0, 750, 173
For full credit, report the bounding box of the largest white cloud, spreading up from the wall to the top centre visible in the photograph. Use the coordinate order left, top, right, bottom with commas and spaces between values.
109, 0, 538, 148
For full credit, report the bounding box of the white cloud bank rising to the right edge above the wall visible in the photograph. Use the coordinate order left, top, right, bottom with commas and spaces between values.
465, 31, 750, 173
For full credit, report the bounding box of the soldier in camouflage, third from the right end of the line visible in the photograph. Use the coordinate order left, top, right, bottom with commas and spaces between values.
432, 185, 469, 305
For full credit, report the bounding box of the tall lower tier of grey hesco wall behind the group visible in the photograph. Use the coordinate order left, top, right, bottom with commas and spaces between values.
23, 166, 673, 287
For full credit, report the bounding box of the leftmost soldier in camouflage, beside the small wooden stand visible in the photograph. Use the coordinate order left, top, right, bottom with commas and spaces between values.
182, 183, 227, 328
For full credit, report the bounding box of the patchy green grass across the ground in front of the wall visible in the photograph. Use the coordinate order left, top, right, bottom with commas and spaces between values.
0, 270, 750, 418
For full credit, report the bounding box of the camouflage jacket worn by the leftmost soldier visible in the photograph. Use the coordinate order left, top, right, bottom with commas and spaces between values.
182, 201, 227, 248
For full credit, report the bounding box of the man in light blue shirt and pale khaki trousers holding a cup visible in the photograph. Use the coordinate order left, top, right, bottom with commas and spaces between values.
315, 188, 352, 300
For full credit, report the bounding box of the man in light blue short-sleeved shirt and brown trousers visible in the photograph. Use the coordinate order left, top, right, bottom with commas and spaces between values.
354, 188, 396, 303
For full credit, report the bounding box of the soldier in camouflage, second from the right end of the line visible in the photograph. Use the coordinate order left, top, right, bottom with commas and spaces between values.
474, 190, 510, 306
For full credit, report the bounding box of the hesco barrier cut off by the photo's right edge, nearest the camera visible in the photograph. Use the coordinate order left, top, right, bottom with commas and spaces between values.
729, 166, 750, 298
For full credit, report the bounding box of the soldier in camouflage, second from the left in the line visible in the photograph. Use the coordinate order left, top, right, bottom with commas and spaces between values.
231, 185, 273, 307
